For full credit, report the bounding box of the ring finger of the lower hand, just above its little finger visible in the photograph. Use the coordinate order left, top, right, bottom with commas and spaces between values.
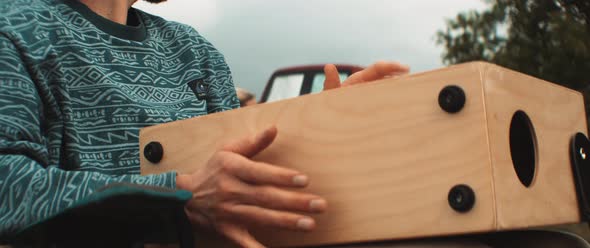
227, 205, 315, 231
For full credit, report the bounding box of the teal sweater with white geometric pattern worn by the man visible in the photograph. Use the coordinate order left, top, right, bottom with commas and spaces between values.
0, 0, 239, 236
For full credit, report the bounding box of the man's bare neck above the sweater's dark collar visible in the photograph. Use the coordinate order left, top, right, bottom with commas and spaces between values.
79, 0, 137, 25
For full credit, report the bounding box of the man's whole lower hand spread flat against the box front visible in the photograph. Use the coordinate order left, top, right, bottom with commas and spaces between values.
177, 127, 327, 247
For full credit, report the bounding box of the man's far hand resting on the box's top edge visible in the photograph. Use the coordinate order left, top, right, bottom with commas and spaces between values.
324, 61, 410, 90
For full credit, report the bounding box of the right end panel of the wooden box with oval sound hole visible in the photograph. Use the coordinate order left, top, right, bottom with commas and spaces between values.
484, 65, 586, 230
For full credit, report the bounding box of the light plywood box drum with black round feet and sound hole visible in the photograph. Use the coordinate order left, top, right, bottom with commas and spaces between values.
140, 62, 587, 247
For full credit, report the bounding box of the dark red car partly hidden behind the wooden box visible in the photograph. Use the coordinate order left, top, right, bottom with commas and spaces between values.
260, 64, 364, 103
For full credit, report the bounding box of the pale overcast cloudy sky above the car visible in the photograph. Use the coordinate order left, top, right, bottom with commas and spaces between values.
135, 0, 486, 97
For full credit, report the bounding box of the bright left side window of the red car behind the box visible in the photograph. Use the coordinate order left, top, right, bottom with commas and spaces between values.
267, 73, 305, 102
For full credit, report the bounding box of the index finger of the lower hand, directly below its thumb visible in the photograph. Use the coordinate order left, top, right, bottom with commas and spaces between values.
224, 153, 309, 187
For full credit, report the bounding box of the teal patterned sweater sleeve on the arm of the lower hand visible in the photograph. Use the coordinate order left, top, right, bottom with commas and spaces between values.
0, 33, 176, 236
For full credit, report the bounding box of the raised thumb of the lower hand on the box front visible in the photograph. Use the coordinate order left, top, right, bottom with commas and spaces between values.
222, 126, 277, 158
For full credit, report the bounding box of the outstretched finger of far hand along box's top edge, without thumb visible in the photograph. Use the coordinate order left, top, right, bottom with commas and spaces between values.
344, 61, 410, 85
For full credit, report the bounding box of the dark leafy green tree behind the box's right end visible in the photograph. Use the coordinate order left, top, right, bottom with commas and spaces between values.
437, 0, 590, 111
